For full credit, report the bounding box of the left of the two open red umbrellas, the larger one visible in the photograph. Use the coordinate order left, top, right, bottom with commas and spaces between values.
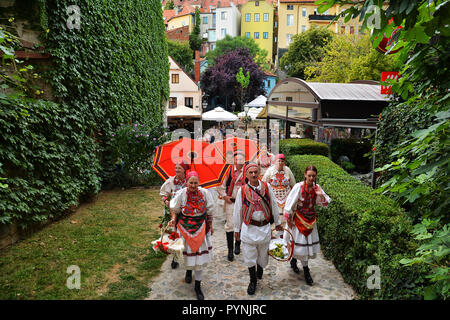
152, 138, 230, 188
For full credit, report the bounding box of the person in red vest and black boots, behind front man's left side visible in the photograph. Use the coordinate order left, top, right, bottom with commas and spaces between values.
217, 150, 245, 261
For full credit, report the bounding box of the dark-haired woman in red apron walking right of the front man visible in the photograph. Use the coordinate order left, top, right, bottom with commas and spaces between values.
284, 166, 331, 285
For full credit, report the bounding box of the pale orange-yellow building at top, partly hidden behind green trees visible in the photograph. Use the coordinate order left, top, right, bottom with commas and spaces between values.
276, 0, 362, 61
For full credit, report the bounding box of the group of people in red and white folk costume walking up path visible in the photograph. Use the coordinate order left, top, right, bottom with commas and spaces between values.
160, 147, 331, 300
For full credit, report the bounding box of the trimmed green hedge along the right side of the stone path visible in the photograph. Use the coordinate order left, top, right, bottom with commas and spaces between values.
289, 155, 429, 299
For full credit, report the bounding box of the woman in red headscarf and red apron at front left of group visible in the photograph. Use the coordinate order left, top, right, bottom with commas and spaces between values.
169, 171, 214, 300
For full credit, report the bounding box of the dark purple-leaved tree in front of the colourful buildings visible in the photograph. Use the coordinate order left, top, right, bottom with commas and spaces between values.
200, 48, 266, 111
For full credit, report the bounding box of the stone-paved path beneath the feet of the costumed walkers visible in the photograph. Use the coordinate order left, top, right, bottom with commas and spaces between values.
147, 200, 356, 300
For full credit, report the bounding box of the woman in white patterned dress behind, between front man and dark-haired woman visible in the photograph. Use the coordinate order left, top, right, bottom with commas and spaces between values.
262, 154, 295, 231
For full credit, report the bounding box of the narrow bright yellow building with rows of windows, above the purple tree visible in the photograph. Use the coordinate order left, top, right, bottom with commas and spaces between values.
241, 0, 276, 63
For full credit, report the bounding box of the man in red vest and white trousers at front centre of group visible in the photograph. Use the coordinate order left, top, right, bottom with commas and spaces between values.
234, 162, 283, 295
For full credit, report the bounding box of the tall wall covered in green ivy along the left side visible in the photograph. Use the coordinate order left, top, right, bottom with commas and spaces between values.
0, 0, 169, 232
